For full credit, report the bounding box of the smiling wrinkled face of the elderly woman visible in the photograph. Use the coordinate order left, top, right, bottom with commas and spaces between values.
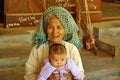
47, 17, 64, 43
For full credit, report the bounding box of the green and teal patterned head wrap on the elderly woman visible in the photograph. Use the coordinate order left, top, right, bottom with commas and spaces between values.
33, 6, 81, 47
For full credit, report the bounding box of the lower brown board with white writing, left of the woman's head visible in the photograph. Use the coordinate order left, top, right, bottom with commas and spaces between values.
5, 13, 41, 28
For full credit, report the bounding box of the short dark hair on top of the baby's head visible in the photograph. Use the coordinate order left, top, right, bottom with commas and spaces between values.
49, 43, 67, 54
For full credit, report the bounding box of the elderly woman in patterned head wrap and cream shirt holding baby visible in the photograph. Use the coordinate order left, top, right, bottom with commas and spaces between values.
24, 6, 84, 80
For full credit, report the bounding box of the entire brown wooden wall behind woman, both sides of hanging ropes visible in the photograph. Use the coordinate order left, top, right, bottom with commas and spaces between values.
4, 0, 101, 27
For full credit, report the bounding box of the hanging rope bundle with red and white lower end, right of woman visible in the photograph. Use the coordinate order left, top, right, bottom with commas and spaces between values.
76, 0, 99, 55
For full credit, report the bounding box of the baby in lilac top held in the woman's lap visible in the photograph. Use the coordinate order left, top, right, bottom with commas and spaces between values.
37, 44, 82, 80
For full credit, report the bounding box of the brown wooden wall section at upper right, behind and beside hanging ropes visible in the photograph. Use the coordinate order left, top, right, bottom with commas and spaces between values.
80, 0, 102, 22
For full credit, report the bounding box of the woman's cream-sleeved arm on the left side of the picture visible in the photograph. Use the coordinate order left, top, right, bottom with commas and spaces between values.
24, 47, 40, 80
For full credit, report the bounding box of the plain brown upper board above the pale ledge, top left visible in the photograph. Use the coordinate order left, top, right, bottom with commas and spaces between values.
5, 0, 45, 14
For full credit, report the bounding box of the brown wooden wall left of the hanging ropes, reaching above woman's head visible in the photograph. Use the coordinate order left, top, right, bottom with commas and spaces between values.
4, 0, 75, 27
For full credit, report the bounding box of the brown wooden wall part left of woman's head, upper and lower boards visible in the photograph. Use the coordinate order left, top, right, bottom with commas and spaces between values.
4, 0, 45, 27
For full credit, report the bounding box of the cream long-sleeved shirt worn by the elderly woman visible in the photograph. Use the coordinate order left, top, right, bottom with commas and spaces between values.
24, 41, 84, 80
